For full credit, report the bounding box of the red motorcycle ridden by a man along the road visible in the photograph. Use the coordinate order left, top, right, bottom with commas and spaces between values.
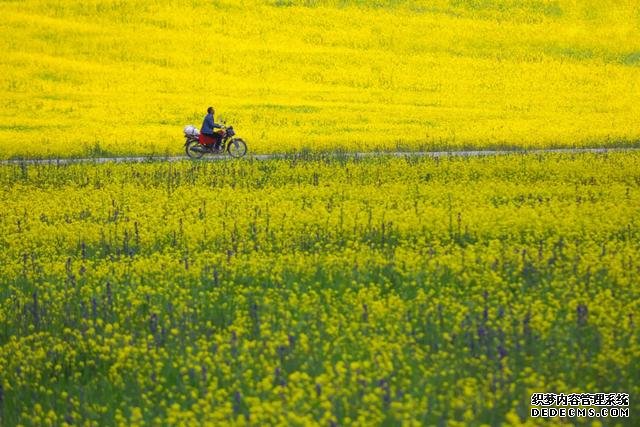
184, 125, 247, 159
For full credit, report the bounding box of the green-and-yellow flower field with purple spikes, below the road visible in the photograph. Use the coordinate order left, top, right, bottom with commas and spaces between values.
0, 152, 640, 426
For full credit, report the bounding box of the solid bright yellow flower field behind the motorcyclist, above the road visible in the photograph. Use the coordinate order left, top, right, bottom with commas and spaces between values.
0, 0, 640, 158
